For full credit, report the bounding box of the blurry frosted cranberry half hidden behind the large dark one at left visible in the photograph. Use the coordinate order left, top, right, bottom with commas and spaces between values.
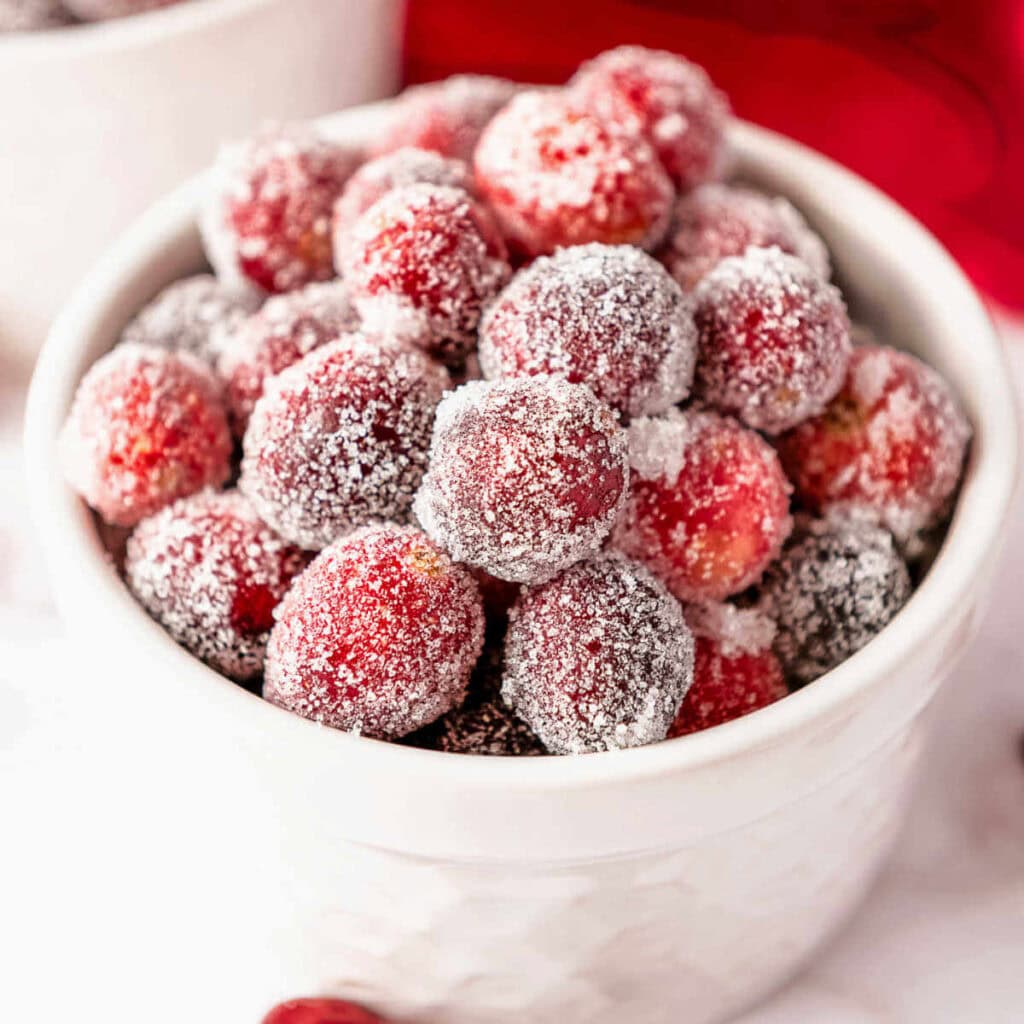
217, 281, 359, 436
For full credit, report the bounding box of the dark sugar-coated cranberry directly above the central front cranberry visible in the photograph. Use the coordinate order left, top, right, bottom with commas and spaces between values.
479, 243, 697, 416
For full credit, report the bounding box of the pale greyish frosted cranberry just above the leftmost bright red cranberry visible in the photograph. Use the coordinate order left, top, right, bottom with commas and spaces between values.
121, 273, 261, 366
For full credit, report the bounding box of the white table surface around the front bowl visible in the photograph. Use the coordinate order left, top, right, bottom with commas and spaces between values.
0, 321, 1024, 1024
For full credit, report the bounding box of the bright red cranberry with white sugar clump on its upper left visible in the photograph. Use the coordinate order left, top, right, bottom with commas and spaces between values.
613, 412, 792, 601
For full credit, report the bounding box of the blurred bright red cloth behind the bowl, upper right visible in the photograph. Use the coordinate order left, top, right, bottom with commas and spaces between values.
404, 0, 1024, 310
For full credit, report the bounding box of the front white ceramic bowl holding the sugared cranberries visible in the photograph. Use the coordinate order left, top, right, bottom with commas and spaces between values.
27, 110, 1017, 1024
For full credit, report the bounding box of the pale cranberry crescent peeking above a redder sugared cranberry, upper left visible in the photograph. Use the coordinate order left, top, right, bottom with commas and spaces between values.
334, 146, 473, 262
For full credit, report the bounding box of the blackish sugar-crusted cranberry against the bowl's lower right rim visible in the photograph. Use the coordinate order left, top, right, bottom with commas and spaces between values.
760, 518, 910, 685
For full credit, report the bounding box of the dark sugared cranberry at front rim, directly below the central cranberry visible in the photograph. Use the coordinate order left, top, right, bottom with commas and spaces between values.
502, 551, 693, 754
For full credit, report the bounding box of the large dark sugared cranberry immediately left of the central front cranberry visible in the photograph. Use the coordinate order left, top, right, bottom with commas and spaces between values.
239, 334, 447, 549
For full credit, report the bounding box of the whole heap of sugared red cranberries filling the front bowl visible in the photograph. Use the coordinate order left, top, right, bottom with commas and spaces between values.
62, 47, 971, 770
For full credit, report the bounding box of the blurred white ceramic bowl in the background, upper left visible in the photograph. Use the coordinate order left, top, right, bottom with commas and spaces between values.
0, 0, 399, 356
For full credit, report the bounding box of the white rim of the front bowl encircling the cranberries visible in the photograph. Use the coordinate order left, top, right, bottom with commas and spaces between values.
25, 108, 1018, 792
